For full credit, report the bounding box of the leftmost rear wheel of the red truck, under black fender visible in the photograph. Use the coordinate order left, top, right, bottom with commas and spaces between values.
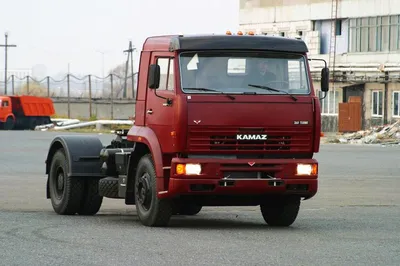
49, 149, 84, 215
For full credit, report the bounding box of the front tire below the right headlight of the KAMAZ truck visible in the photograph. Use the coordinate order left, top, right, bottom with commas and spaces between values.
260, 196, 300, 227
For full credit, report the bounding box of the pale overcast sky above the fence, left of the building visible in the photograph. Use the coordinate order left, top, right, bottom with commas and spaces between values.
0, 0, 239, 76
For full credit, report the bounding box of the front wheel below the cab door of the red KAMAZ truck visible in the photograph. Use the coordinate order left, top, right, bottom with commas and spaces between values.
135, 154, 172, 227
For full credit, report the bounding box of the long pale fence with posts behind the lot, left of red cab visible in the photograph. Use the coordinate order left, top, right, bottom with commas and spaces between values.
0, 73, 137, 99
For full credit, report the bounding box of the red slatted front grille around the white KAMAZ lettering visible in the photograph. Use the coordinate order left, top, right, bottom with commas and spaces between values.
188, 126, 312, 152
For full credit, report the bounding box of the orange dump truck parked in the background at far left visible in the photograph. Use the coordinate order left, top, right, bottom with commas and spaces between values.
0, 95, 55, 130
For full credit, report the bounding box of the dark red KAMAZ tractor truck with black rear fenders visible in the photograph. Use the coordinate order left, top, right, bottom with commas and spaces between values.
45, 31, 329, 226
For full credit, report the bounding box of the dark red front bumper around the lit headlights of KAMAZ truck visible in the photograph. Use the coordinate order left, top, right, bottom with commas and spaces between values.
158, 158, 318, 198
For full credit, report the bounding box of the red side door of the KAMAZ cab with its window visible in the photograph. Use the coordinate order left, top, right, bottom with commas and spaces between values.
145, 52, 176, 152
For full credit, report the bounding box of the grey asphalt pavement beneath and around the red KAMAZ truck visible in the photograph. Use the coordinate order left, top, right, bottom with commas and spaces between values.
0, 131, 400, 266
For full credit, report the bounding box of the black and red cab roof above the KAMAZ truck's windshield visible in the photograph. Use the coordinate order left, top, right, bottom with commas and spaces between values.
143, 35, 308, 53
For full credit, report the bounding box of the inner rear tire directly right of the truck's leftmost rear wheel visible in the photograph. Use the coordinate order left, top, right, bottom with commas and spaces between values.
78, 179, 103, 215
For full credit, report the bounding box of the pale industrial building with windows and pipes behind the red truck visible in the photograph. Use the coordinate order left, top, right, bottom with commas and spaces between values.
239, 0, 400, 131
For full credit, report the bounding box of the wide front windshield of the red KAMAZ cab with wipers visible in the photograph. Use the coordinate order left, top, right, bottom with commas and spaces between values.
179, 51, 310, 94
